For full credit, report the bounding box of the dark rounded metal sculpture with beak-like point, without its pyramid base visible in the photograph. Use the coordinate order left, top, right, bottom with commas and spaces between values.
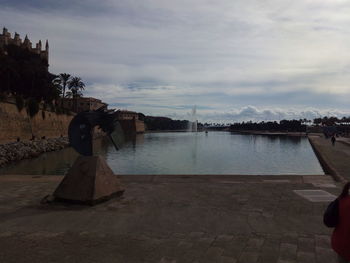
68, 107, 121, 156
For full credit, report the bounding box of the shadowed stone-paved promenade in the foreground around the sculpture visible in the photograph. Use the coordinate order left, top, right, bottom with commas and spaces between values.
0, 175, 340, 263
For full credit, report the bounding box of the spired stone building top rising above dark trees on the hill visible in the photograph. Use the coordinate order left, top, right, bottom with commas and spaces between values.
0, 27, 49, 63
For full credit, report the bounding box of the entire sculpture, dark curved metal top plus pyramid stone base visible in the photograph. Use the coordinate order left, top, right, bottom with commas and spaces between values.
53, 107, 124, 205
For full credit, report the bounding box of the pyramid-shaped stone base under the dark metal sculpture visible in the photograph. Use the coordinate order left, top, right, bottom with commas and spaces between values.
53, 156, 124, 205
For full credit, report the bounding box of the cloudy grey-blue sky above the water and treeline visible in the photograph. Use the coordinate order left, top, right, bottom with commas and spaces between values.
0, 0, 350, 123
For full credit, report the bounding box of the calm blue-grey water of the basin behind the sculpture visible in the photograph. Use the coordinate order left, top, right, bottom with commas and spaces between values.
0, 132, 324, 175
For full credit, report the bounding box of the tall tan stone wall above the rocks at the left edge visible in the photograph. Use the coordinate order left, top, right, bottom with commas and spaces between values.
0, 101, 73, 143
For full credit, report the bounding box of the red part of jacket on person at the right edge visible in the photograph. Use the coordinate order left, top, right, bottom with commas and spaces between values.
332, 196, 350, 260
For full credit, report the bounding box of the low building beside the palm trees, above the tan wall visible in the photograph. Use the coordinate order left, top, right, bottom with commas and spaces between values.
59, 97, 108, 113
